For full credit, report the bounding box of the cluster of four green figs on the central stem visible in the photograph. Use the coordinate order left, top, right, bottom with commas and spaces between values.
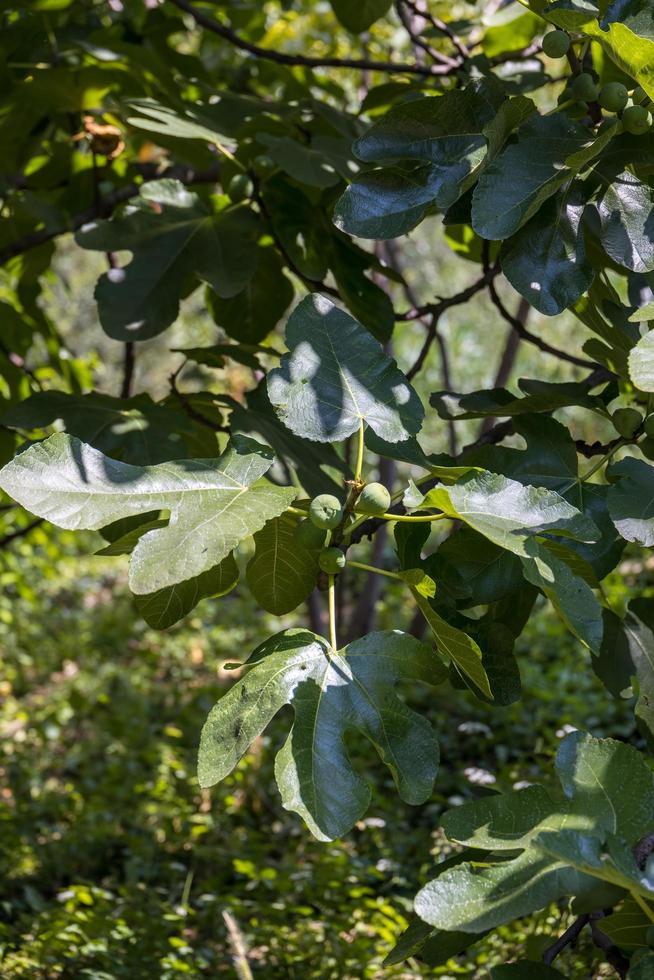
295, 483, 391, 575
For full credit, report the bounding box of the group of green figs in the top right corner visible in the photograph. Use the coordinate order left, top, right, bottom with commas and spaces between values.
543, 30, 652, 136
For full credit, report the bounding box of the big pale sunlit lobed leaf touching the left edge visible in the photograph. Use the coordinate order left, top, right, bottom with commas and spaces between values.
0, 433, 296, 595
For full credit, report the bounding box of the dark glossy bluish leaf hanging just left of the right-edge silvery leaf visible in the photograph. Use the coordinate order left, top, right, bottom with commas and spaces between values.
501, 194, 594, 316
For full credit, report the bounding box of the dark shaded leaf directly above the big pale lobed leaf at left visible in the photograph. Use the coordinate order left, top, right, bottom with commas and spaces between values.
1, 391, 218, 465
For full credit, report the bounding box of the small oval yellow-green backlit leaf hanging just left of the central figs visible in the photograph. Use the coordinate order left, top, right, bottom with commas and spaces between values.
246, 515, 318, 616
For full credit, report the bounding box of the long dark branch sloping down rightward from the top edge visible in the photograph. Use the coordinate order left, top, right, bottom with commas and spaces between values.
168, 0, 462, 77
